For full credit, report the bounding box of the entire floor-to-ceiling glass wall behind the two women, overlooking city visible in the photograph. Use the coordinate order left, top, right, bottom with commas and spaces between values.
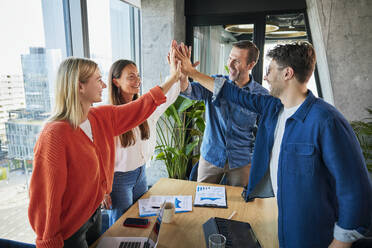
0, 0, 141, 243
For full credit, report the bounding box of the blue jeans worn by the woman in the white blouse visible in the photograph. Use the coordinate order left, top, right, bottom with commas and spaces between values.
109, 165, 147, 226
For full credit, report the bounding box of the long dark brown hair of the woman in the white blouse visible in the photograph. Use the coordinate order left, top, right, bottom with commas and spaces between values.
108, 59, 150, 147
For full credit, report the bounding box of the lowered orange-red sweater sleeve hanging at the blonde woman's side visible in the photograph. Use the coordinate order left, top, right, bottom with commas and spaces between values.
28, 123, 67, 248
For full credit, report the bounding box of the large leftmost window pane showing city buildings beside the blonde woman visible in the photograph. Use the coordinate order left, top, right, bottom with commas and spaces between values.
0, 0, 51, 240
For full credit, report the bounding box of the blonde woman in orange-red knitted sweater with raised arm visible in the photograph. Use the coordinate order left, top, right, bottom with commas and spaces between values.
28, 52, 180, 248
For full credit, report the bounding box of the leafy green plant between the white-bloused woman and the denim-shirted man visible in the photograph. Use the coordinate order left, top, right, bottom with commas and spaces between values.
155, 96, 205, 179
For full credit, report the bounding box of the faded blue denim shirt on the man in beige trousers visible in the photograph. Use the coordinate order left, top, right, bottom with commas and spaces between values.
181, 75, 268, 169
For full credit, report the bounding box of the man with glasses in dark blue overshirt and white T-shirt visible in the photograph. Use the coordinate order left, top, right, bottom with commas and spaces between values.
177, 42, 372, 248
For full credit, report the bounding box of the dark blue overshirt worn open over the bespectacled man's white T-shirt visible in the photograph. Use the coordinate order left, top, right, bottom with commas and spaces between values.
213, 78, 372, 248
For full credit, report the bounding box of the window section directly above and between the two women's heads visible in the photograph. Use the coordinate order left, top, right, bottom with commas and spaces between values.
87, 0, 141, 104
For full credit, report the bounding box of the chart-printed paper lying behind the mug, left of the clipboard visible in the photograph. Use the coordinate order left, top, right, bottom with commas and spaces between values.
138, 195, 192, 217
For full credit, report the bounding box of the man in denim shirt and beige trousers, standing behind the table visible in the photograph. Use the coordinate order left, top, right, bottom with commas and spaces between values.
181, 41, 268, 186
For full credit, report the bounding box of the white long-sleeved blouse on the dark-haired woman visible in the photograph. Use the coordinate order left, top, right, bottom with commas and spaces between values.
115, 82, 180, 172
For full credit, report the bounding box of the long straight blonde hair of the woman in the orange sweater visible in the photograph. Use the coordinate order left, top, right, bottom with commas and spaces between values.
49, 57, 98, 128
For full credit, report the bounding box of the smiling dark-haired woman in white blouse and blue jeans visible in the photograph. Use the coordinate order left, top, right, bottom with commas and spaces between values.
108, 60, 182, 226
